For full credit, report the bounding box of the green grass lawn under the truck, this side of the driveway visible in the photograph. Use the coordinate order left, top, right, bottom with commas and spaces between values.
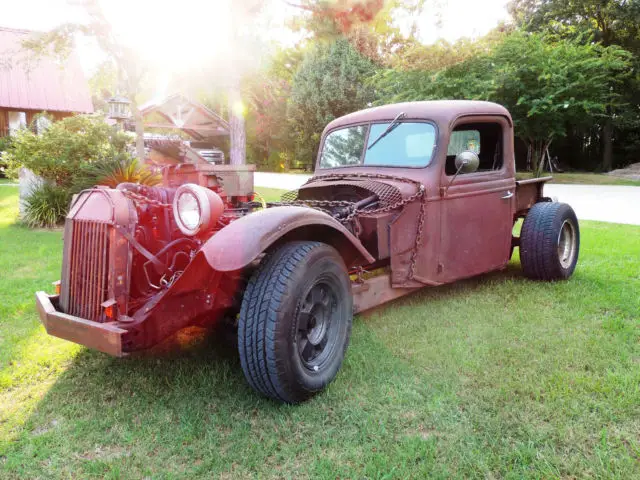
0, 187, 640, 479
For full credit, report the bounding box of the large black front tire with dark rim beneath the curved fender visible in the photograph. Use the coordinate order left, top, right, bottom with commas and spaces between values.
238, 242, 353, 403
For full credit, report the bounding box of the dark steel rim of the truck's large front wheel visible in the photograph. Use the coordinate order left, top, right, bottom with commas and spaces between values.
296, 280, 340, 372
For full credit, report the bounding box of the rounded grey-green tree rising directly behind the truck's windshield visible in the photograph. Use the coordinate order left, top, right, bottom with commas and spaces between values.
287, 39, 376, 163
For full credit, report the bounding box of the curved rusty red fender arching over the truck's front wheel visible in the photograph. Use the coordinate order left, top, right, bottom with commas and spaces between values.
201, 207, 375, 272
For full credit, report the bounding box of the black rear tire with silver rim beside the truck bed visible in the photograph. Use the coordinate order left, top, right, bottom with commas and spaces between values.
520, 202, 580, 281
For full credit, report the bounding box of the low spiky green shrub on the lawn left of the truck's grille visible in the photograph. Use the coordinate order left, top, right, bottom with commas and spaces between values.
23, 181, 71, 227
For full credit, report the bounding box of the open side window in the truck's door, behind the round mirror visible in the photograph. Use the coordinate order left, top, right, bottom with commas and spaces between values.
445, 123, 503, 175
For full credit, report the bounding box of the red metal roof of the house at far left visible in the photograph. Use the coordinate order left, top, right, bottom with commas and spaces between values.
0, 27, 93, 113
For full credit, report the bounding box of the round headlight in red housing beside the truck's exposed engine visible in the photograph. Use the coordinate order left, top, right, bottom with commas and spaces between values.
173, 183, 224, 236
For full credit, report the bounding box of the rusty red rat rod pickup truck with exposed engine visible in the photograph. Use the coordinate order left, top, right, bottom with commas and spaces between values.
36, 101, 580, 403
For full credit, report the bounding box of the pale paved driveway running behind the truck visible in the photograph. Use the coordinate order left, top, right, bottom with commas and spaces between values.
255, 172, 640, 225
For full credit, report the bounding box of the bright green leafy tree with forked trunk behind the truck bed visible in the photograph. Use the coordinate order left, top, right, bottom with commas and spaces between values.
491, 33, 631, 173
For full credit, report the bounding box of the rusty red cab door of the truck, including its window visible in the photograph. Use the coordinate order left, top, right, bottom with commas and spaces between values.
437, 117, 515, 282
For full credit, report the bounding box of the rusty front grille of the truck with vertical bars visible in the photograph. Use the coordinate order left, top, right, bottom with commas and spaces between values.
60, 219, 112, 321
